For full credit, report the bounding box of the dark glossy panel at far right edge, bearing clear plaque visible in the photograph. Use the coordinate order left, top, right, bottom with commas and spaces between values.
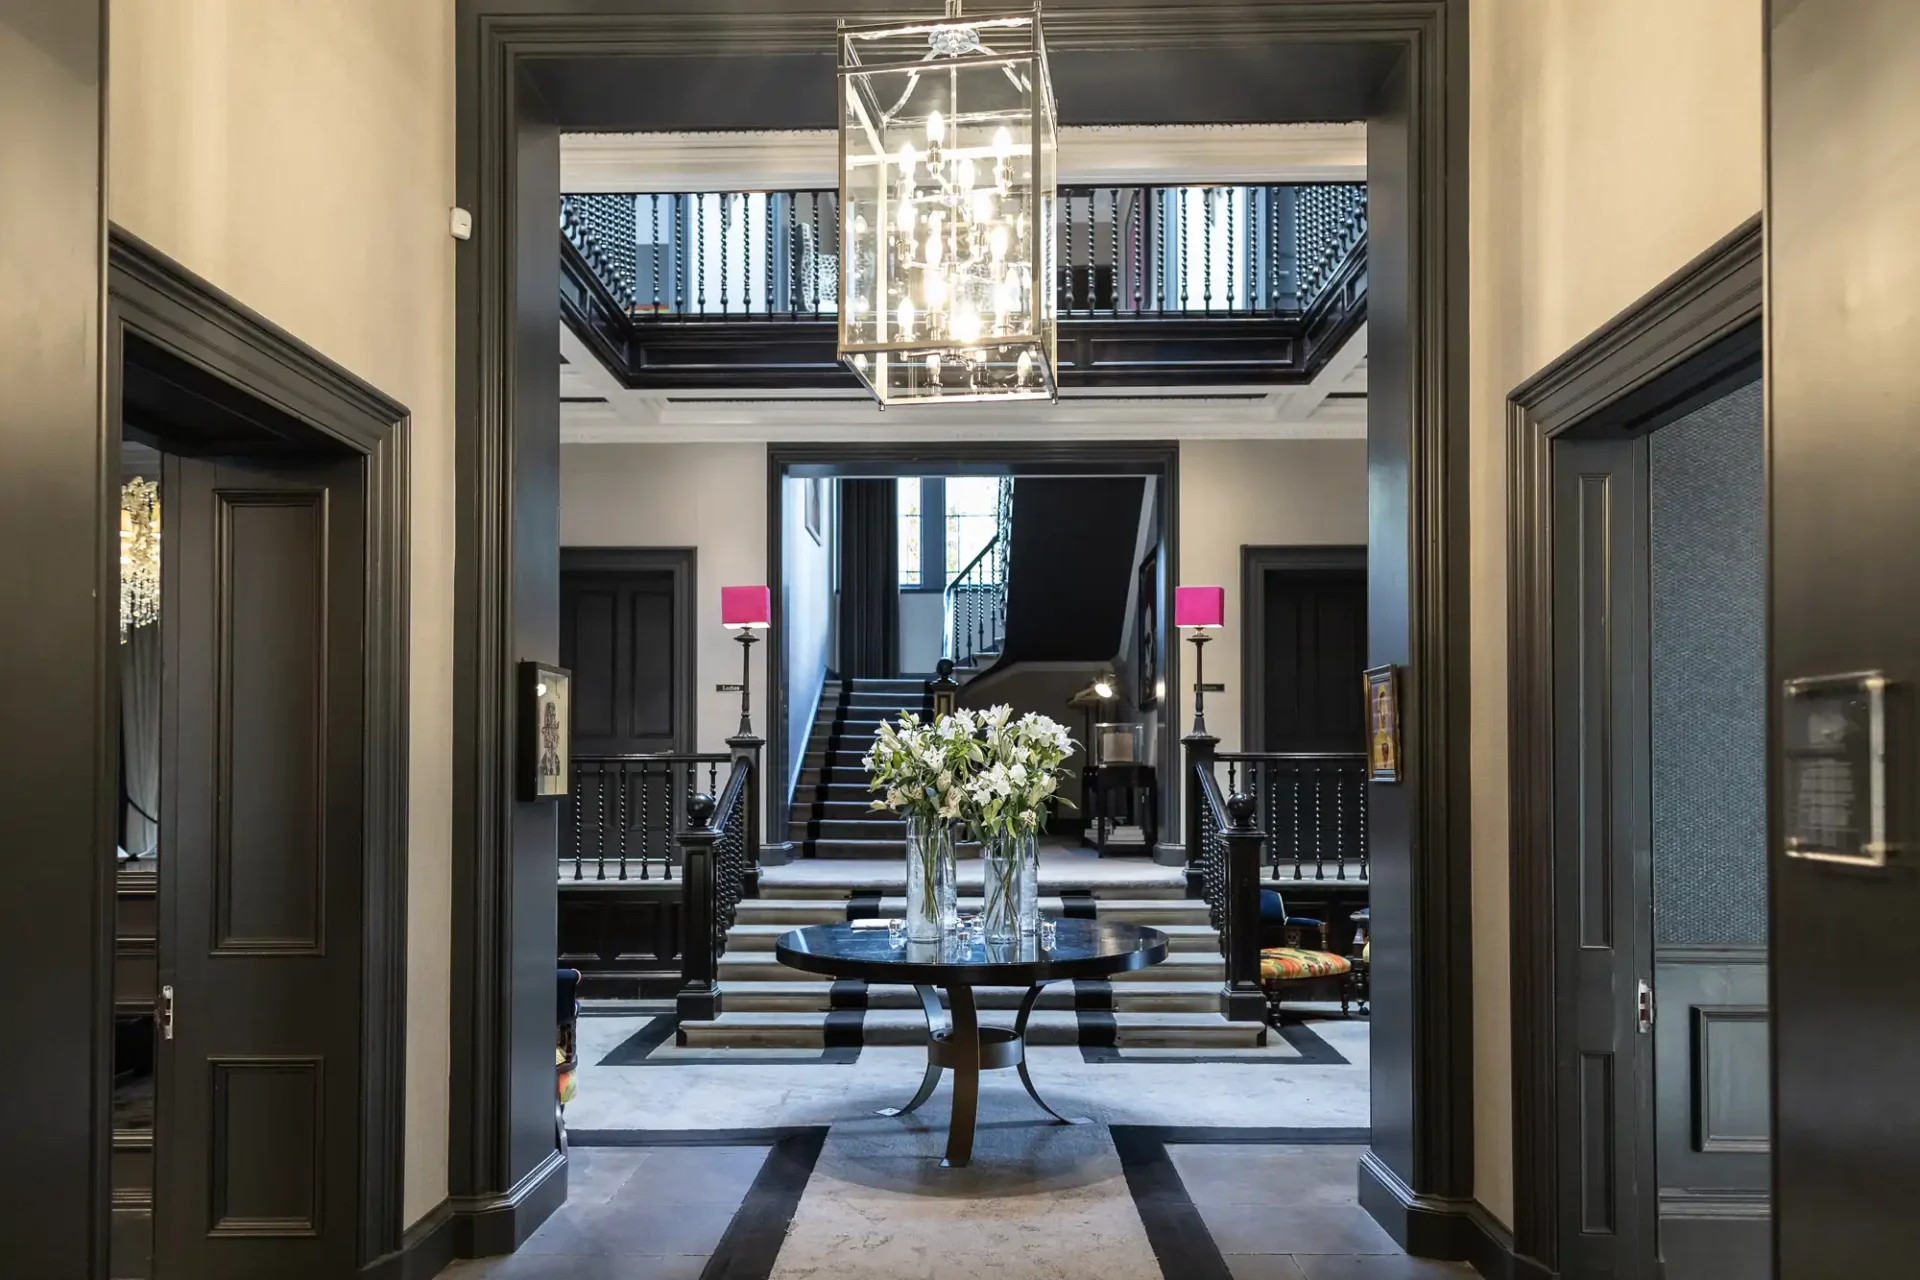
1764, 0, 1920, 1280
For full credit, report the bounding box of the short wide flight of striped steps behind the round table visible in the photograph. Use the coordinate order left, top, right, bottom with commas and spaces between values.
680, 875, 1265, 1050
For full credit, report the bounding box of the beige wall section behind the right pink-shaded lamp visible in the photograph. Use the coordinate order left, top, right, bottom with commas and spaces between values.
1167, 439, 1367, 750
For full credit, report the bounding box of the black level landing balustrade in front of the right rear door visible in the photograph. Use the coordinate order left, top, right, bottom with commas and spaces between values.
1215, 752, 1369, 885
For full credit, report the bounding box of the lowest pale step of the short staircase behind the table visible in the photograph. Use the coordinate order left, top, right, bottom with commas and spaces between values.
680, 996, 1267, 1050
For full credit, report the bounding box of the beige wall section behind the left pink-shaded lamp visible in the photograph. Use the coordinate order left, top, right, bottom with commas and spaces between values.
561, 445, 772, 750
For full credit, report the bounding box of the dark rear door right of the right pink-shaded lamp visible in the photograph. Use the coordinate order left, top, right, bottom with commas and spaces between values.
1256, 562, 1367, 752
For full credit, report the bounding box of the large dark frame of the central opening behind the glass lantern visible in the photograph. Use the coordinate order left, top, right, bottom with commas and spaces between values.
449, 0, 1474, 1257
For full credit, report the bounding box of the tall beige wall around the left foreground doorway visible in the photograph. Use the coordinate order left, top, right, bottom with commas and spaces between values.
108, 0, 453, 1222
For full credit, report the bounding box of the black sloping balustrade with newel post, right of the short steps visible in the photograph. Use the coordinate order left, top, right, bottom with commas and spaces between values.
1188, 760, 1267, 1023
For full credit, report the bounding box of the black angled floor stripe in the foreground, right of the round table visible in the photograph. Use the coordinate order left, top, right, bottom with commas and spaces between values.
1108, 1125, 1371, 1280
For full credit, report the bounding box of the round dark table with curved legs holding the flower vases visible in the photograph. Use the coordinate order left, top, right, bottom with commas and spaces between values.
774, 919, 1167, 1169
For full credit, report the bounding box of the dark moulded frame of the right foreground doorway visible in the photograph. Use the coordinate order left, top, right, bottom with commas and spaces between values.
1507, 217, 1763, 1274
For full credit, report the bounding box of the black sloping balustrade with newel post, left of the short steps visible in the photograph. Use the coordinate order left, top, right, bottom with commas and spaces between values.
674, 750, 760, 1021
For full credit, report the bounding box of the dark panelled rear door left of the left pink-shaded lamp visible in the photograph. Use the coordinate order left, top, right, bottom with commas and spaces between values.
561, 568, 691, 758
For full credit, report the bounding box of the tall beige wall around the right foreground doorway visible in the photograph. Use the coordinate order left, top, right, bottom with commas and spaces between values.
1469, 0, 1763, 1224
